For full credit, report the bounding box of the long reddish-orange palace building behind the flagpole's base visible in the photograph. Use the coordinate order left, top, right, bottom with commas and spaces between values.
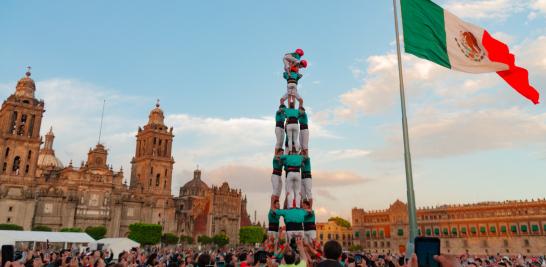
352, 199, 546, 255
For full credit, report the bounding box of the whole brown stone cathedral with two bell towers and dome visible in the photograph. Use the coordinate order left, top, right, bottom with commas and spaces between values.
0, 71, 251, 243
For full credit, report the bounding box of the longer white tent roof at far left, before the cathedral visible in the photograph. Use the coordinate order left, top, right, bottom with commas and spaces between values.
0, 230, 95, 247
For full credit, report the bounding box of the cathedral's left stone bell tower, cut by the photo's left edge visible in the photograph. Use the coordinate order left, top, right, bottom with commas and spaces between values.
0, 67, 45, 181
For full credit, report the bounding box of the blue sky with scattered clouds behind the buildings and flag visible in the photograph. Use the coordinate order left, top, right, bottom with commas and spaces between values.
0, 0, 546, 223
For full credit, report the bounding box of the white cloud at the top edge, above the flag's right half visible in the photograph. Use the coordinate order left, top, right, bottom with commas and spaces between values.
443, 0, 529, 20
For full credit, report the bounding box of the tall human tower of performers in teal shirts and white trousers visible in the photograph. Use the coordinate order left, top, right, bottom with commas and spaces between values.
268, 49, 316, 246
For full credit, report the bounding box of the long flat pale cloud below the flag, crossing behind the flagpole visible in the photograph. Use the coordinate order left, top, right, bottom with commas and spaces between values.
371, 107, 546, 159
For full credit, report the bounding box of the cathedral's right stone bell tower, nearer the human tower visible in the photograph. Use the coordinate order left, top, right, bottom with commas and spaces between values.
131, 100, 174, 195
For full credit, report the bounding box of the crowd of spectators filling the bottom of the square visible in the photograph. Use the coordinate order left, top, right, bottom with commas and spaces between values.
3, 238, 546, 267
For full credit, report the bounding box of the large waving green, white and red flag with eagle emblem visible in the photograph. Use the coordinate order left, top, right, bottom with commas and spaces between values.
400, 0, 539, 104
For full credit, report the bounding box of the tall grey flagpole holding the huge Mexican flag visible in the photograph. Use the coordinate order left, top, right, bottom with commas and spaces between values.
392, 0, 417, 259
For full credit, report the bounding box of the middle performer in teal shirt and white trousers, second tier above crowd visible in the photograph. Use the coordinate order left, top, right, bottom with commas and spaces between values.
279, 152, 303, 209
